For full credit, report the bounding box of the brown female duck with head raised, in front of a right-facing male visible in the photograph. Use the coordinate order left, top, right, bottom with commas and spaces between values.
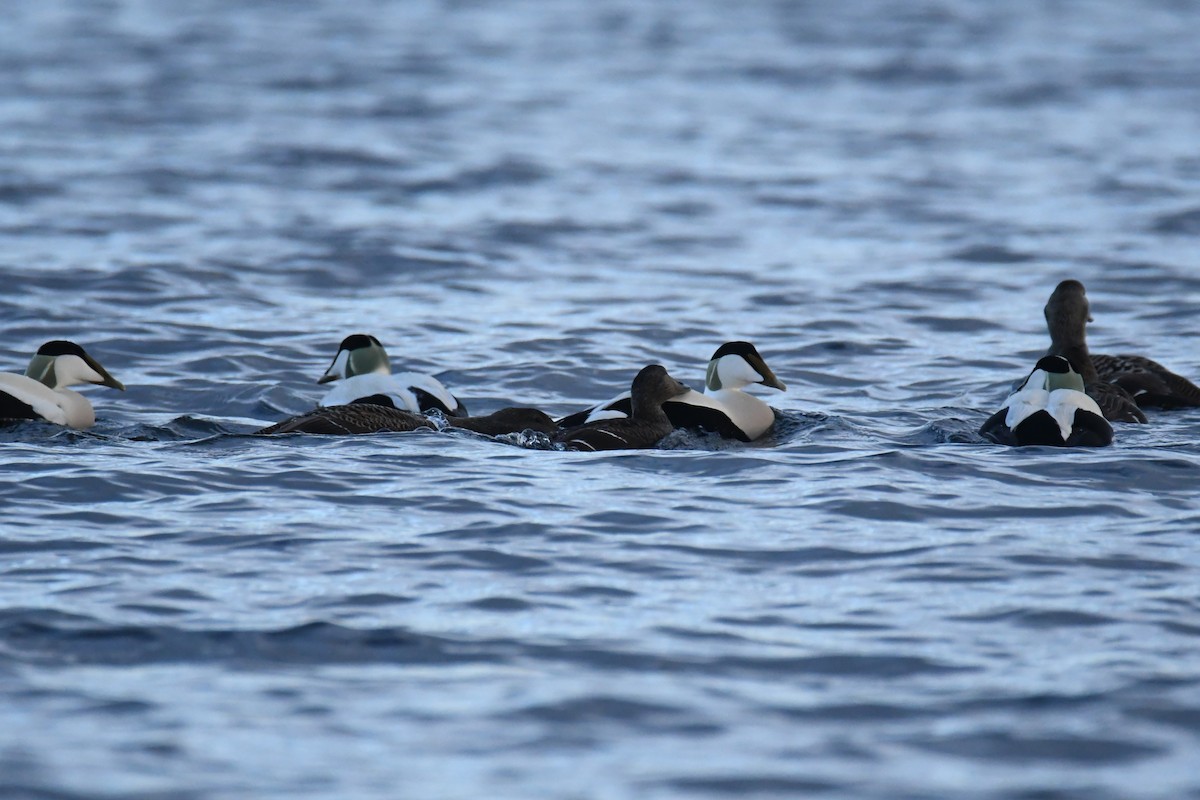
553, 363, 691, 450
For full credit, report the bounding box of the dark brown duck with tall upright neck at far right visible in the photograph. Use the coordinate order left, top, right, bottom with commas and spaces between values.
1045, 281, 1200, 422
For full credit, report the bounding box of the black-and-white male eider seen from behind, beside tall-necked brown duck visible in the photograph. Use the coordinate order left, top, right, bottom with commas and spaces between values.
979, 355, 1112, 447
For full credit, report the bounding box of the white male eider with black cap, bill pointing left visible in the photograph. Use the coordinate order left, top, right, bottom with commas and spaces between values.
317, 333, 467, 417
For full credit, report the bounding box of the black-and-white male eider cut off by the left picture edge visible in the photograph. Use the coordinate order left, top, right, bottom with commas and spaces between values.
0, 341, 125, 428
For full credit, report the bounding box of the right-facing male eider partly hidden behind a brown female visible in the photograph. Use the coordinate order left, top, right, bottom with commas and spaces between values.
558, 342, 787, 441
